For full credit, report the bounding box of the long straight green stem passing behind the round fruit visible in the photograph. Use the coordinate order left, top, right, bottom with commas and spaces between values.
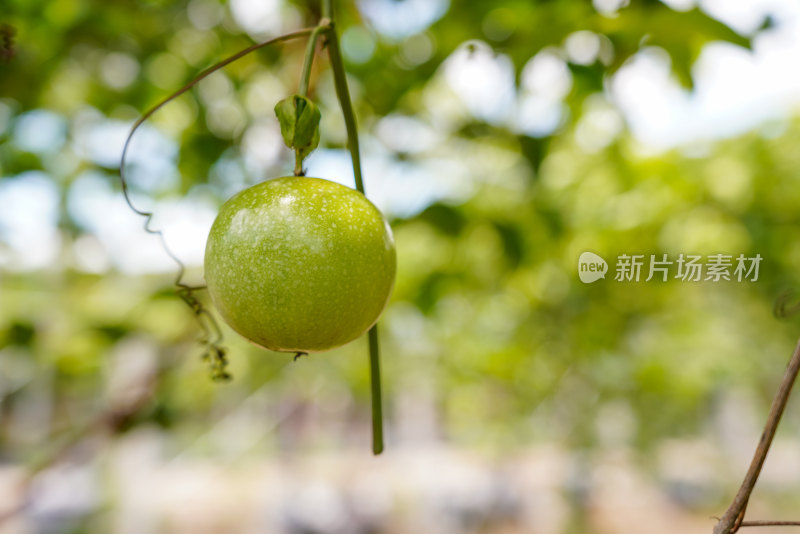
322, 0, 383, 455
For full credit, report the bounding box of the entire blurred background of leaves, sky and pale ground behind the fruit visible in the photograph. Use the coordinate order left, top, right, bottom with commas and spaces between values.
0, 0, 800, 534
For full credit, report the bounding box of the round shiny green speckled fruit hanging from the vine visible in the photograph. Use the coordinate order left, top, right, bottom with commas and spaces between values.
205, 176, 397, 352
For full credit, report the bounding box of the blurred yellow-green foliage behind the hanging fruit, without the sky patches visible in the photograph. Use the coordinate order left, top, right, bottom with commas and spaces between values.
0, 0, 788, 464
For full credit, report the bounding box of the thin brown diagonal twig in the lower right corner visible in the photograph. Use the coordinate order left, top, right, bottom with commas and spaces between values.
714, 341, 800, 534
